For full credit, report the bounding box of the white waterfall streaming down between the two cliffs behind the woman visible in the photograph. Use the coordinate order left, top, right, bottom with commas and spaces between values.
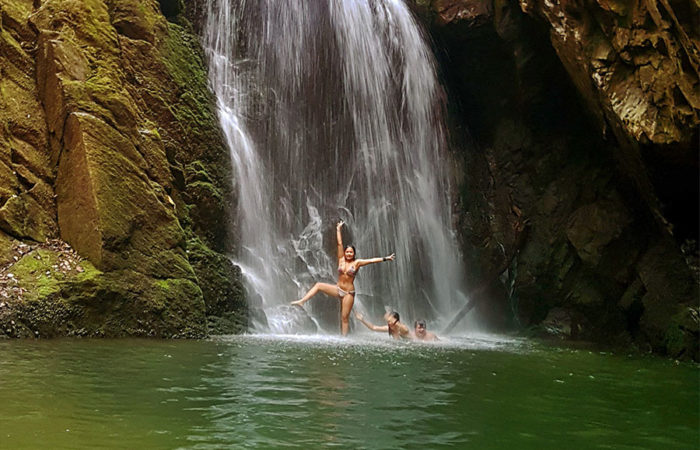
204, 0, 474, 332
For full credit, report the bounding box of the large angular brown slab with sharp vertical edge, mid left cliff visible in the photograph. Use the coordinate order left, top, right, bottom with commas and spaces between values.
57, 114, 192, 278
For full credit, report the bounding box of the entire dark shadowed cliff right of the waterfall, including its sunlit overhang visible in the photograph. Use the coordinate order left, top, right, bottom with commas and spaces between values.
415, 0, 700, 360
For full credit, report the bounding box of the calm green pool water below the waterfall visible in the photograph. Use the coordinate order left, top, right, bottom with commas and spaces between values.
0, 335, 700, 450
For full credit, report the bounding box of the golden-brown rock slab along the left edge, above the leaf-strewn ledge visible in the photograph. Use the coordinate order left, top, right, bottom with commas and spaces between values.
0, 0, 57, 246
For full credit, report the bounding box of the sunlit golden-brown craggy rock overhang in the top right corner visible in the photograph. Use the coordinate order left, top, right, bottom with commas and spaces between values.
520, 0, 700, 146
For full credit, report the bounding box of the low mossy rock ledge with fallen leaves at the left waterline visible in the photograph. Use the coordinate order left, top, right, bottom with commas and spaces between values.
0, 249, 206, 338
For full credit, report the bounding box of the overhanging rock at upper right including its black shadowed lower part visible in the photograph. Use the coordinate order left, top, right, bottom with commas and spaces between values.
520, 0, 700, 243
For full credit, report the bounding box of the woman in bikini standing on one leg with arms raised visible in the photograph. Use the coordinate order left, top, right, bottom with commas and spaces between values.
292, 220, 394, 336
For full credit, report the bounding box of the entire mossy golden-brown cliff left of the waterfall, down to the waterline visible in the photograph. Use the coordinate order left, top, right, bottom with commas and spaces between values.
0, 0, 245, 337
